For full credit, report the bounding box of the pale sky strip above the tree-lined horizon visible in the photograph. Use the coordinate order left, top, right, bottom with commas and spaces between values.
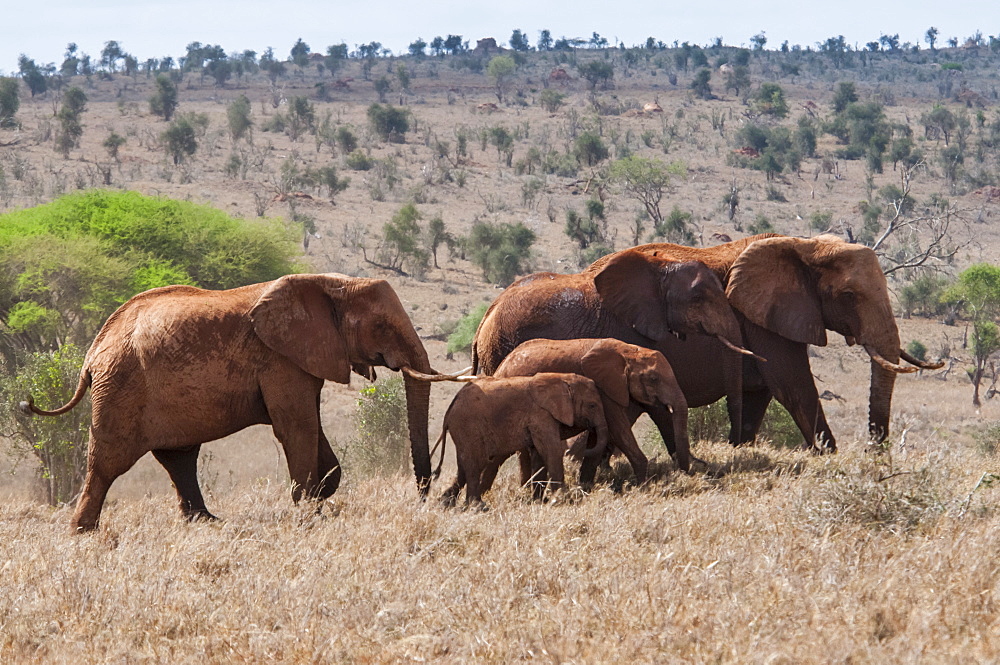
0, 0, 1000, 74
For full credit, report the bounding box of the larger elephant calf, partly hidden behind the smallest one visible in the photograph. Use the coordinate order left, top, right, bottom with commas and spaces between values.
494, 339, 690, 488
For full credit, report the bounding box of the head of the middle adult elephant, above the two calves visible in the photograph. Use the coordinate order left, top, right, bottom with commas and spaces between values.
594, 250, 749, 354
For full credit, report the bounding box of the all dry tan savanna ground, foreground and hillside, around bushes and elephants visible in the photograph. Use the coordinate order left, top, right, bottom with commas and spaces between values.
0, 45, 1000, 664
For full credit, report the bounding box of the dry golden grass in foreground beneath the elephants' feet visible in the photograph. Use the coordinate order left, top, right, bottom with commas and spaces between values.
0, 436, 1000, 663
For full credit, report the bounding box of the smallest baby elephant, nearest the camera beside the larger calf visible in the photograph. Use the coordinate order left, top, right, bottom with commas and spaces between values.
438, 372, 608, 509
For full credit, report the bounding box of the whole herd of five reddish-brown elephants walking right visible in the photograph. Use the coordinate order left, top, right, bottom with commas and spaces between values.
21, 234, 938, 531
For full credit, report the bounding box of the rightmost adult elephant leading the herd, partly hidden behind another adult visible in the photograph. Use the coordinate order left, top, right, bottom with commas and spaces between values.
584, 234, 941, 450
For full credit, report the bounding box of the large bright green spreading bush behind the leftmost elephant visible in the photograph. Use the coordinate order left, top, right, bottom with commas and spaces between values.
0, 190, 301, 362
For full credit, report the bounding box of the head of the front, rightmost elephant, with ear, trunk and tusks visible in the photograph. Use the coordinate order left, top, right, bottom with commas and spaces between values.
727, 235, 931, 441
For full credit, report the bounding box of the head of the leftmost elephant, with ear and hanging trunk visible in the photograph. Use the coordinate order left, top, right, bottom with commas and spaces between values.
250, 274, 434, 494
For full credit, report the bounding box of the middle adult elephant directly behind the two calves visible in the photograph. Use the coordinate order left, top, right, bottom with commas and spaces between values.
472, 250, 750, 460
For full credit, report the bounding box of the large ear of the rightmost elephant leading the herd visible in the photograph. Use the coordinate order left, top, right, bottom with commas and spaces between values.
726, 237, 826, 346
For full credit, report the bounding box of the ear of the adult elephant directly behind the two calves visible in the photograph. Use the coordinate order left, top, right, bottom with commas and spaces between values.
594, 250, 670, 341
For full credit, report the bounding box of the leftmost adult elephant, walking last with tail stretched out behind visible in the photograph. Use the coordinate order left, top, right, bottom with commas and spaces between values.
21, 274, 434, 530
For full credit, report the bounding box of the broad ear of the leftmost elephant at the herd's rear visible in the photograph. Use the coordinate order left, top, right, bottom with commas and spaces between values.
250, 275, 351, 383
